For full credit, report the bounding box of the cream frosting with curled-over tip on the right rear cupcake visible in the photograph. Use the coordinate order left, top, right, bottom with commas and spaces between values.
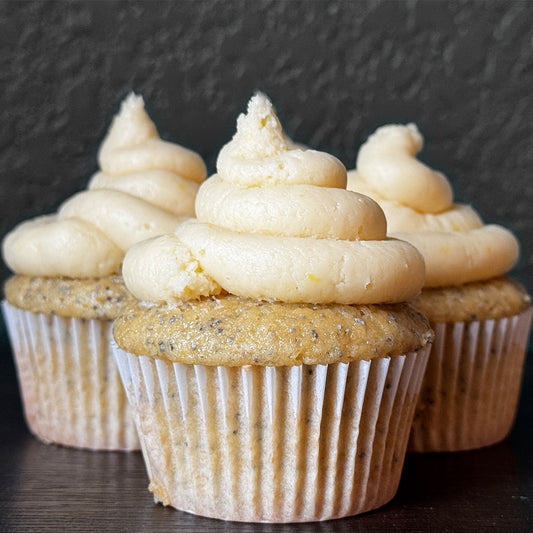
347, 124, 519, 287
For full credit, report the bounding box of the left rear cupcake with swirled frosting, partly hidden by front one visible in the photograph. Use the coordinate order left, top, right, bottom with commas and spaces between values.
2, 94, 206, 450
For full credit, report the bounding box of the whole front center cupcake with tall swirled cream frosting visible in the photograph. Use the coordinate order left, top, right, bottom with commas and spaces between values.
114, 94, 432, 522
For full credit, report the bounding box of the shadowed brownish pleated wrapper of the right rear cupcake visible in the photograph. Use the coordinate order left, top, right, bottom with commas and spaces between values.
409, 309, 532, 452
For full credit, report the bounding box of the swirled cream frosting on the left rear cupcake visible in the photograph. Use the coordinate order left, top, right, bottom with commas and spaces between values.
3, 94, 206, 278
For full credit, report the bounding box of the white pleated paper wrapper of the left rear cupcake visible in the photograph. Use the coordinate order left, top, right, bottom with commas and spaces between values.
2, 301, 140, 450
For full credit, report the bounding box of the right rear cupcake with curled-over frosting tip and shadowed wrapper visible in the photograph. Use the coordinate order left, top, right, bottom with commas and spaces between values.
348, 124, 531, 452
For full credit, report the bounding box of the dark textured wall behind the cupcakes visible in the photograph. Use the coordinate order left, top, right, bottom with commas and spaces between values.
0, 0, 533, 291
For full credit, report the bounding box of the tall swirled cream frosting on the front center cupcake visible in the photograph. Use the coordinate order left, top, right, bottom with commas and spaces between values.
123, 94, 424, 304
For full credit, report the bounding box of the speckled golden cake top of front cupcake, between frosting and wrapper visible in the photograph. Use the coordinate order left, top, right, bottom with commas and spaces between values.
113, 295, 432, 366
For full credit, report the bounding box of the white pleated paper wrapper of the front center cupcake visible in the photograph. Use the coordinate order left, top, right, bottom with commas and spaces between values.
115, 342, 428, 522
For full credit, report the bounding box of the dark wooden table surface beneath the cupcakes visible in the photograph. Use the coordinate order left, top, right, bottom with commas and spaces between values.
0, 339, 533, 533
